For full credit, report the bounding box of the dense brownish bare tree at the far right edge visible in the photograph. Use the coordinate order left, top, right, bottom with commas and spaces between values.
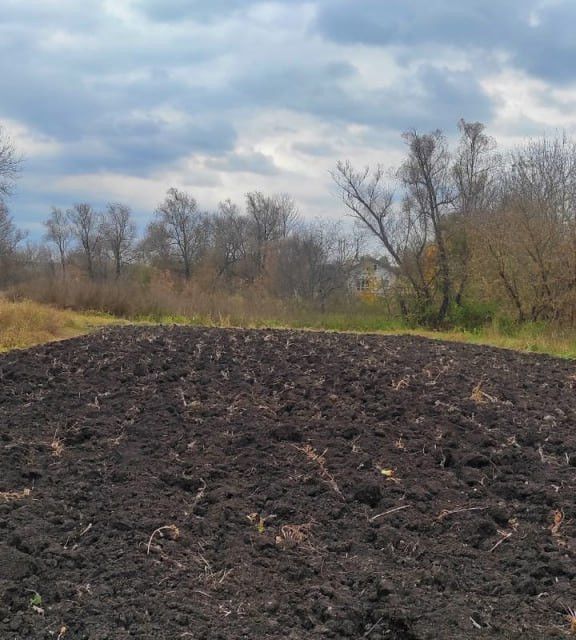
477, 135, 576, 321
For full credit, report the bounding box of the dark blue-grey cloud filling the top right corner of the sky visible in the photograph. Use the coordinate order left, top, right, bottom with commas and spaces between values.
316, 0, 576, 82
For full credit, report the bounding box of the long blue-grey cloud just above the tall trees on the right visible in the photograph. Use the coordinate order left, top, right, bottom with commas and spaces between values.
228, 63, 492, 130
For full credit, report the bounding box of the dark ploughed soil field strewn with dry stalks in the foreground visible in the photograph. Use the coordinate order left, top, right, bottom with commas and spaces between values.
0, 328, 576, 640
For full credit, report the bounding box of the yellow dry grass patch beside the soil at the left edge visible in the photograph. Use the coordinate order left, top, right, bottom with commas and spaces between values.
0, 298, 119, 352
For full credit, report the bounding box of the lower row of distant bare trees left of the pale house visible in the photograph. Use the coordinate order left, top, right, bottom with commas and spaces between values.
0, 168, 361, 308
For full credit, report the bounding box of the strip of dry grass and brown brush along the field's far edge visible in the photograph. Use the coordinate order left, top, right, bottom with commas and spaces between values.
5, 278, 576, 364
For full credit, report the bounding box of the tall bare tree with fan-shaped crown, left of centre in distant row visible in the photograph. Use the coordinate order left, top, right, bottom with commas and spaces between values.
156, 188, 209, 280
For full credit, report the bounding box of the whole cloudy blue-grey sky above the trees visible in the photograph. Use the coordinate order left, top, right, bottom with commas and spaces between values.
0, 0, 576, 236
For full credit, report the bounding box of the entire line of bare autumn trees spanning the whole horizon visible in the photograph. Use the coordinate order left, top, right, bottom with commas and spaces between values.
0, 120, 576, 326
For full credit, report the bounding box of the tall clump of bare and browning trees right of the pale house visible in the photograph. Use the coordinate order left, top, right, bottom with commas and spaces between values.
333, 120, 576, 325
